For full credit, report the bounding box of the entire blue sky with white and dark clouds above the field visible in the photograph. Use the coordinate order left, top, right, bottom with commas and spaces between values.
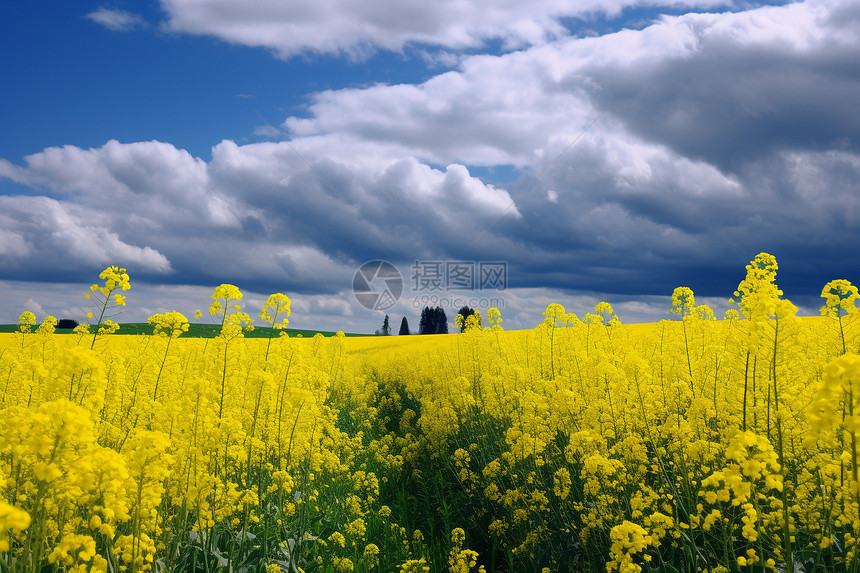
0, 0, 860, 332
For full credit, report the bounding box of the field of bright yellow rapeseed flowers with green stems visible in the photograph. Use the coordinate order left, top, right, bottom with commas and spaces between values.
0, 253, 860, 573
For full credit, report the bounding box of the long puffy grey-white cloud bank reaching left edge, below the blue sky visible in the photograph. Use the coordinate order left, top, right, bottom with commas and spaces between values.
0, 136, 520, 291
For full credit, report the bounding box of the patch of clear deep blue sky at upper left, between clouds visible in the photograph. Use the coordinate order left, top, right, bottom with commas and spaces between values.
0, 2, 428, 158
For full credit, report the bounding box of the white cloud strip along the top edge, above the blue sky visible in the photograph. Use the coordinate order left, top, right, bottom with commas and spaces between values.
162, 0, 726, 58
